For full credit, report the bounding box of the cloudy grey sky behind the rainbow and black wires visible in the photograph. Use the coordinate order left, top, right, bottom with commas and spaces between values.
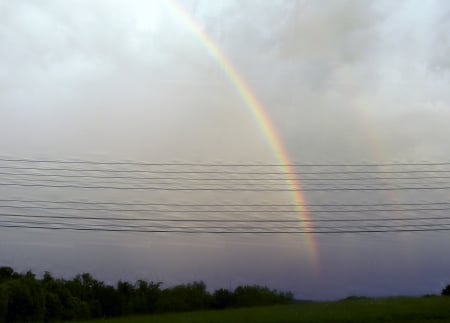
0, 0, 450, 299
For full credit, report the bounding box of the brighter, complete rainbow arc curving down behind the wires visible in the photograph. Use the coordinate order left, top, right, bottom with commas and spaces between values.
166, 0, 318, 269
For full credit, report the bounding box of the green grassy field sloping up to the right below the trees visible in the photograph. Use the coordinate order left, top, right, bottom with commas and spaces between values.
77, 296, 450, 323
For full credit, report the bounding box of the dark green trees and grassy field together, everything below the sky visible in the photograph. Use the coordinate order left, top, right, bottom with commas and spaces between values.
0, 267, 450, 323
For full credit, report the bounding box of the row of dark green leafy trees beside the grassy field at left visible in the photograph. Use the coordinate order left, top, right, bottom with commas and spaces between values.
0, 267, 294, 323
